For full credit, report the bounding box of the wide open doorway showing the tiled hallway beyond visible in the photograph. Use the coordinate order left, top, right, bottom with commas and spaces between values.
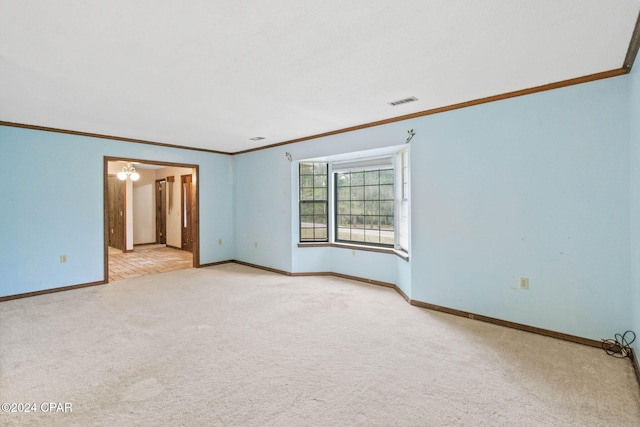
104, 157, 200, 282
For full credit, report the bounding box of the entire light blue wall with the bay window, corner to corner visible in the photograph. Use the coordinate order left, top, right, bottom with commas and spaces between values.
235, 76, 633, 340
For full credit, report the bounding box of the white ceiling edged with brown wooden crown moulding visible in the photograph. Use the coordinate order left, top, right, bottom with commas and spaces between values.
0, 0, 640, 153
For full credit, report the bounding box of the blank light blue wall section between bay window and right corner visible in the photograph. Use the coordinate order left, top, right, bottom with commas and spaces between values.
412, 77, 632, 339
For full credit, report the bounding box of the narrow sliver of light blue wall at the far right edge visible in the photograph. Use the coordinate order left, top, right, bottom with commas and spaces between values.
629, 64, 640, 350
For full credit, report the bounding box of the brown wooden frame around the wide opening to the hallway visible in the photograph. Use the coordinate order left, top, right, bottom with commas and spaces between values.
102, 156, 200, 283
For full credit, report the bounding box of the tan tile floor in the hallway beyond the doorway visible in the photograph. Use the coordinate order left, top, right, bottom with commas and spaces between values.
109, 245, 193, 282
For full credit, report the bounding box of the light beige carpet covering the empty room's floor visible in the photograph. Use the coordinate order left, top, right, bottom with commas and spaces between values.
0, 264, 640, 426
